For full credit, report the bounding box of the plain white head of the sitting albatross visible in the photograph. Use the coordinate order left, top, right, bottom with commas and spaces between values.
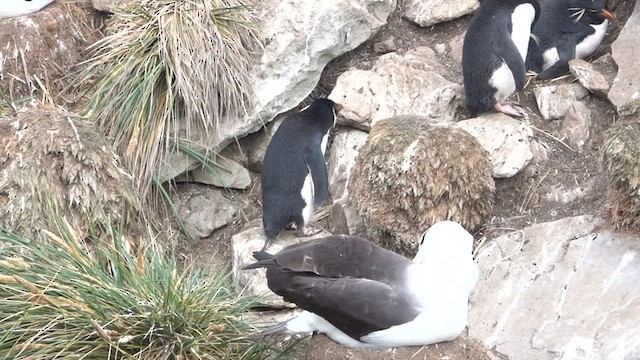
413, 220, 473, 264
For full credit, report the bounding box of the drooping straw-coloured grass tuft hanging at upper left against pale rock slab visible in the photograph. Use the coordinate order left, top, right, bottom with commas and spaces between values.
75, 0, 259, 196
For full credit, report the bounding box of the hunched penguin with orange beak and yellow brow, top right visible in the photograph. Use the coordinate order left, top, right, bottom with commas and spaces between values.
527, 0, 613, 80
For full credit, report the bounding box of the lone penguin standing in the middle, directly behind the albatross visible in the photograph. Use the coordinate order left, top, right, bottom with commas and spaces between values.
261, 98, 341, 250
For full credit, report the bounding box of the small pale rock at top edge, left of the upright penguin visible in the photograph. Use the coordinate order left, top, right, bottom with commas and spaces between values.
403, 0, 480, 27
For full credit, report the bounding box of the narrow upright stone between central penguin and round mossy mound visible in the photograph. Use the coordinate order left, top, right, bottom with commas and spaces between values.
327, 129, 369, 200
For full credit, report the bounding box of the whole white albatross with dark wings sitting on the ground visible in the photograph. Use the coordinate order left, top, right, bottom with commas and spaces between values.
244, 221, 478, 348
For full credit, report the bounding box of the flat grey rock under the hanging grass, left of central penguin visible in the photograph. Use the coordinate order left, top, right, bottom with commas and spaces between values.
175, 156, 251, 190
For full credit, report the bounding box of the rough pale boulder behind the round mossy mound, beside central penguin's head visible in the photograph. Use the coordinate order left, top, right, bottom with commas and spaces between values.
329, 47, 464, 130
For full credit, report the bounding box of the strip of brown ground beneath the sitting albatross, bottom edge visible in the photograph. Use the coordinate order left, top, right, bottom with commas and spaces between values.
306, 334, 497, 360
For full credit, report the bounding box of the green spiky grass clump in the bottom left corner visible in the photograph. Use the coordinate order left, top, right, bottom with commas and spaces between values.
0, 218, 283, 359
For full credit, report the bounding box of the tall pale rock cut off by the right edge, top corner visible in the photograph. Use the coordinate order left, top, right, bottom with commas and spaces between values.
608, 2, 640, 115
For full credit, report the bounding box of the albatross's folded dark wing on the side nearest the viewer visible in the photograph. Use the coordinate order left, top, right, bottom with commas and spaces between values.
267, 267, 418, 340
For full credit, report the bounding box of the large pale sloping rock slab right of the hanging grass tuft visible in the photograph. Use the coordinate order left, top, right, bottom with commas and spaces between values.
214, 0, 396, 148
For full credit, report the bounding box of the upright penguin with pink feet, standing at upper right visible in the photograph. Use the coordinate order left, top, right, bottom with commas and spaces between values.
462, 0, 540, 116
